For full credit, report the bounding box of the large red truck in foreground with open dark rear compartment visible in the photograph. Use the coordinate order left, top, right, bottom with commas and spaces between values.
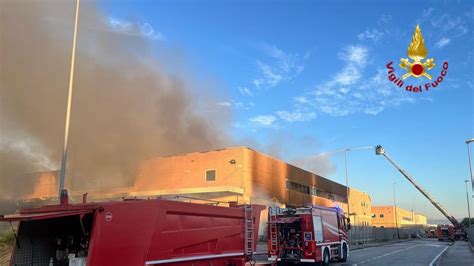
0, 193, 265, 266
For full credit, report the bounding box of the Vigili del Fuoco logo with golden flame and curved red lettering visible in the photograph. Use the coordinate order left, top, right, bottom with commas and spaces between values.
387, 25, 448, 92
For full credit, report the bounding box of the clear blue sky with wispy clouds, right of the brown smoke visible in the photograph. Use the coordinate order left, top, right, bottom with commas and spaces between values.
100, 1, 474, 217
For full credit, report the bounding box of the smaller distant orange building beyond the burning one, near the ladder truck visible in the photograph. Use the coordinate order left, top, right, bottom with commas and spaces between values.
372, 206, 427, 228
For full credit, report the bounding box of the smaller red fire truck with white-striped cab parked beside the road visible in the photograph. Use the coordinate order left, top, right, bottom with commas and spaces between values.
268, 206, 350, 265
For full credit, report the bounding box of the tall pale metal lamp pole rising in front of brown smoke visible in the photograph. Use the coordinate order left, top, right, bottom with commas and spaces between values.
59, 0, 80, 200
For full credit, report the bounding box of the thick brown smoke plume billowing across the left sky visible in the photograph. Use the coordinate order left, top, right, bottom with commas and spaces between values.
0, 0, 229, 203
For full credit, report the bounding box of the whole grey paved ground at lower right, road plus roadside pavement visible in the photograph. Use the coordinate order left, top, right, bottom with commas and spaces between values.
258, 239, 474, 266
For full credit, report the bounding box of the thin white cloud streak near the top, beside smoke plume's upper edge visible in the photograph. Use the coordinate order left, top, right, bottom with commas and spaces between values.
108, 17, 165, 40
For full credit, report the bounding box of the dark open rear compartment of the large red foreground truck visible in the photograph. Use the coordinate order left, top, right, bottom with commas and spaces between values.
12, 213, 93, 266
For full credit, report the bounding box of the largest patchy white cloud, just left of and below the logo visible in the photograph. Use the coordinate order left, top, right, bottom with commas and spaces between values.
300, 46, 414, 116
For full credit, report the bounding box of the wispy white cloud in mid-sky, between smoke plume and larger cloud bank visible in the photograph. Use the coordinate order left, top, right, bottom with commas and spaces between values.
252, 45, 310, 88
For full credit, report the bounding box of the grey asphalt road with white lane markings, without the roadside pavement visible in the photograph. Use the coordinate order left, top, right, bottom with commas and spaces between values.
332, 239, 449, 266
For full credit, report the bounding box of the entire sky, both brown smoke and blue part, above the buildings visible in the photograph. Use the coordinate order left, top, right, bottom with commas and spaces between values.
0, 0, 474, 220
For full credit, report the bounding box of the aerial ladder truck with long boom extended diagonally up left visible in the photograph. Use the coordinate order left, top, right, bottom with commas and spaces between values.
375, 145, 466, 240
